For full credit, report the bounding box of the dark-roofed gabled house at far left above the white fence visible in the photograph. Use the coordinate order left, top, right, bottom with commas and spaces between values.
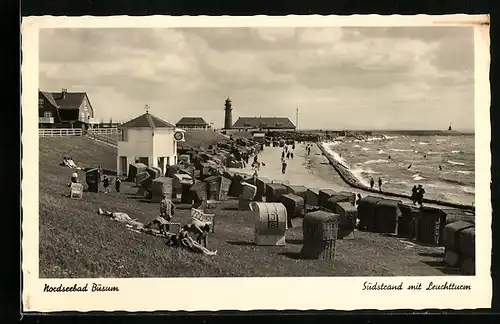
38, 89, 94, 128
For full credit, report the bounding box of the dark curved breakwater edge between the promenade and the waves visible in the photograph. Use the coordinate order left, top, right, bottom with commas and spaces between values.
316, 143, 474, 211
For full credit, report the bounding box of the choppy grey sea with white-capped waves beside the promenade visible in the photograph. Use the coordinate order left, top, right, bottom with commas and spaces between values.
321, 135, 475, 205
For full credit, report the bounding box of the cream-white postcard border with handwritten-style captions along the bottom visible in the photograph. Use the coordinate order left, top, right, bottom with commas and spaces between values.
21, 15, 492, 312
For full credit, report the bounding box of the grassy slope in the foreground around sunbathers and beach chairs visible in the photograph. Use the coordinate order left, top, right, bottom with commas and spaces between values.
39, 137, 456, 278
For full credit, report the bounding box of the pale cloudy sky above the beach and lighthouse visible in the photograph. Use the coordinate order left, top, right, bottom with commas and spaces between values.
39, 27, 474, 130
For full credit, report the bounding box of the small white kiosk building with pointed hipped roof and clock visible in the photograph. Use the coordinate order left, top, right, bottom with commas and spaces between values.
116, 112, 184, 176
